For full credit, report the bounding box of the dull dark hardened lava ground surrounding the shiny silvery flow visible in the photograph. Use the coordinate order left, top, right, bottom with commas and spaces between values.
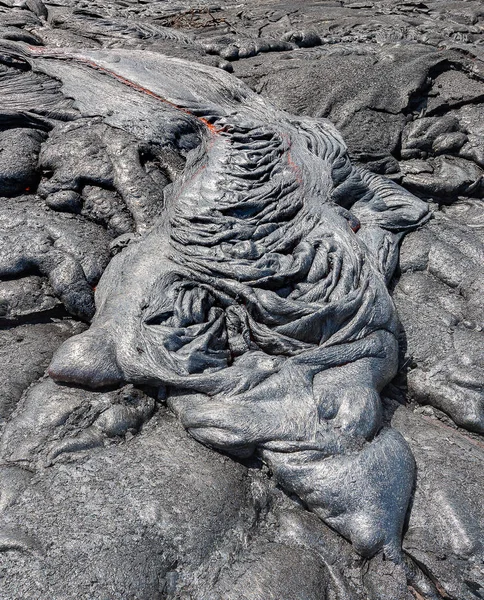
0, 0, 484, 600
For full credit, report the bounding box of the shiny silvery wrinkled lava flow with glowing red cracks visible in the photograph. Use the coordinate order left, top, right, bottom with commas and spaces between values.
0, 46, 428, 562
